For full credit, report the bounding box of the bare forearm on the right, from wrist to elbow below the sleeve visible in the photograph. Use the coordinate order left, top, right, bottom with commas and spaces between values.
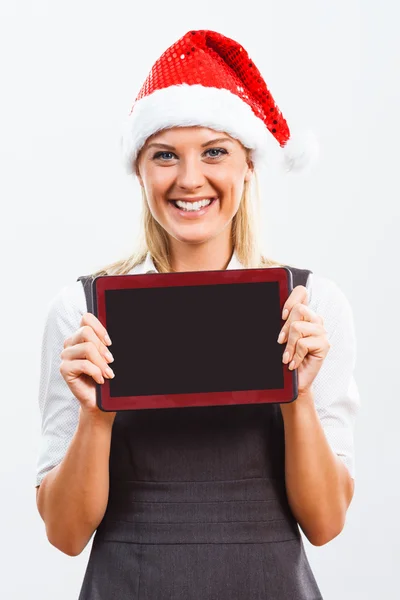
281, 393, 354, 546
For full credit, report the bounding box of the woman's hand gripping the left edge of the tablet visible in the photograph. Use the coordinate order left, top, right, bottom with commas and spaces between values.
60, 312, 116, 422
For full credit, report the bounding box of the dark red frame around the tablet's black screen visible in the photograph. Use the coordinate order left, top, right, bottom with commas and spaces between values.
92, 267, 298, 411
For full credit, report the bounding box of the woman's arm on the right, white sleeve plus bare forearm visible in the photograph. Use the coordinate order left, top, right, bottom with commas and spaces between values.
281, 276, 359, 546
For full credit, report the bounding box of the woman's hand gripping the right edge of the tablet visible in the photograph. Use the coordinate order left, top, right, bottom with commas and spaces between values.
278, 285, 330, 396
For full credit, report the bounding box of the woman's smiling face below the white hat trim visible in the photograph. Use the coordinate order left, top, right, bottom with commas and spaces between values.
136, 127, 252, 250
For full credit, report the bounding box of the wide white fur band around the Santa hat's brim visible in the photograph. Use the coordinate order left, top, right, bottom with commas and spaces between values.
121, 83, 280, 173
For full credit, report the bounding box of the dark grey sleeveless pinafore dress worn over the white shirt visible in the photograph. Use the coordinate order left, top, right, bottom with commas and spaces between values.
78, 267, 322, 600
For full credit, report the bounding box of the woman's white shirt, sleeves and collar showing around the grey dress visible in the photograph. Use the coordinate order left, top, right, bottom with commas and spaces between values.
36, 253, 360, 485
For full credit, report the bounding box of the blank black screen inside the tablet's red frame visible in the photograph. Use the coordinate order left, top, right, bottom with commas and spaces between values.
105, 282, 284, 397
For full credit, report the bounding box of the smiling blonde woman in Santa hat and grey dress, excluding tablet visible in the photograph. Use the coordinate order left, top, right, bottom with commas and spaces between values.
37, 31, 358, 600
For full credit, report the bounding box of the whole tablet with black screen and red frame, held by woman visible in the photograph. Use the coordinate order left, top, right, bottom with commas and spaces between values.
92, 267, 297, 411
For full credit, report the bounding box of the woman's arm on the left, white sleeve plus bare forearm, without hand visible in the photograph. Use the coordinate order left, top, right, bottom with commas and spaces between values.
36, 282, 113, 556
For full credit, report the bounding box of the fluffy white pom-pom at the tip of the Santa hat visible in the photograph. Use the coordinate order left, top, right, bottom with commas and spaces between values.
281, 130, 319, 173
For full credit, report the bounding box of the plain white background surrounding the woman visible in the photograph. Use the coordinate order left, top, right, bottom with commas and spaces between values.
0, 0, 400, 600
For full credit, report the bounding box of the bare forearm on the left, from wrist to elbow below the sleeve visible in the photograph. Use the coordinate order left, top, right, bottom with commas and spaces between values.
36, 409, 112, 556
